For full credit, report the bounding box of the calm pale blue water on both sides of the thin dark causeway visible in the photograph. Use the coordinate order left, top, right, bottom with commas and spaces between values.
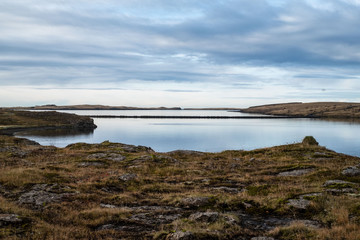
18, 111, 360, 156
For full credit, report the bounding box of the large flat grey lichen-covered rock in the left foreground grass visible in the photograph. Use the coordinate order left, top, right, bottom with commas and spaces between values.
18, 184, 74, 209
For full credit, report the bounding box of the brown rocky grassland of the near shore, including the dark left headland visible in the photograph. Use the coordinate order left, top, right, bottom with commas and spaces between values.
0, 111, 360, 240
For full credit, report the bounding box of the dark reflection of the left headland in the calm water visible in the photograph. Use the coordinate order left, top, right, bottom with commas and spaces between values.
17, 129, 94, 137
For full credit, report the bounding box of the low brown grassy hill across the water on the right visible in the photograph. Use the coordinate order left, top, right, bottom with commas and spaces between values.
240, 102, 360, 118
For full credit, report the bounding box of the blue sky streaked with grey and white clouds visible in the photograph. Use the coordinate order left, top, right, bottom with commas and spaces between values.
0, 0, 360, 107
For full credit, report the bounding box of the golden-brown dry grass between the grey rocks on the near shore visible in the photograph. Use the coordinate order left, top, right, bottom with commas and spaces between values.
0, 133, 360, 240
